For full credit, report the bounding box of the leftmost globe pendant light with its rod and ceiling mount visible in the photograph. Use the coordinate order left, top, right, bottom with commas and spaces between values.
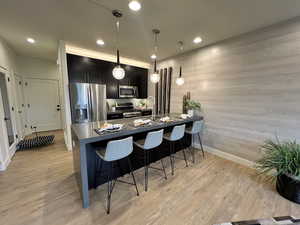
112, 10, 125, 80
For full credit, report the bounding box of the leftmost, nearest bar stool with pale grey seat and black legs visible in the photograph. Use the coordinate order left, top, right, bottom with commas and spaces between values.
96, 137, 139, 214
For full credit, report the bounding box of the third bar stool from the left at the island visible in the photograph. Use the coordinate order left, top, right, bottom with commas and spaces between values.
164, 124, 188, 175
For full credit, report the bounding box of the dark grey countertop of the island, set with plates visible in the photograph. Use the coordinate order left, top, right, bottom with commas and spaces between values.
72, 114, 203, 143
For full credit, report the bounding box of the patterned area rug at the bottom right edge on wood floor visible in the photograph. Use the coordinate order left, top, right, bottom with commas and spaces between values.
215, 216, 300, 225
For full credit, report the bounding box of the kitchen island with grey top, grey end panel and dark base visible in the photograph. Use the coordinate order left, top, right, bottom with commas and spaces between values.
72, 114, 203, 208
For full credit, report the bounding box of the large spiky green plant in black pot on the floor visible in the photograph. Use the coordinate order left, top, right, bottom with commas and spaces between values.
257, 139, 300, 204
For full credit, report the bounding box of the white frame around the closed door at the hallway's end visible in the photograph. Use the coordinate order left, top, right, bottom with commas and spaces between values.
23, 77, 63, 133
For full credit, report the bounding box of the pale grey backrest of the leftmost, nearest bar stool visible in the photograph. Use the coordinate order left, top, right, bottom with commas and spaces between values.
104, 137, 133, 161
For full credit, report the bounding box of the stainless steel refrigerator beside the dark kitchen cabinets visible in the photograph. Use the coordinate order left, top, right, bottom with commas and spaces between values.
70, 83, 107, 123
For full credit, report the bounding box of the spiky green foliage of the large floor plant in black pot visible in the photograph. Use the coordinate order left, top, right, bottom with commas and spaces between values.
256, 138, 300, 182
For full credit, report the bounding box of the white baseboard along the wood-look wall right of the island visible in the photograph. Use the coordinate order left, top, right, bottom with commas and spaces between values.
194, 144, 255, 168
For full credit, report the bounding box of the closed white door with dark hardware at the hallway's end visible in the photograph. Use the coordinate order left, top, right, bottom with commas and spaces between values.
24, 79, 61, 131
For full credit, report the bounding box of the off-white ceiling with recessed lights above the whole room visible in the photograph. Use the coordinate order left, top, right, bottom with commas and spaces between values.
0, 0, 300, 61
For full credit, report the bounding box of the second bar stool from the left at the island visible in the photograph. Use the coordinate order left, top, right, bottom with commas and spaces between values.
134, 129, 168, 191
